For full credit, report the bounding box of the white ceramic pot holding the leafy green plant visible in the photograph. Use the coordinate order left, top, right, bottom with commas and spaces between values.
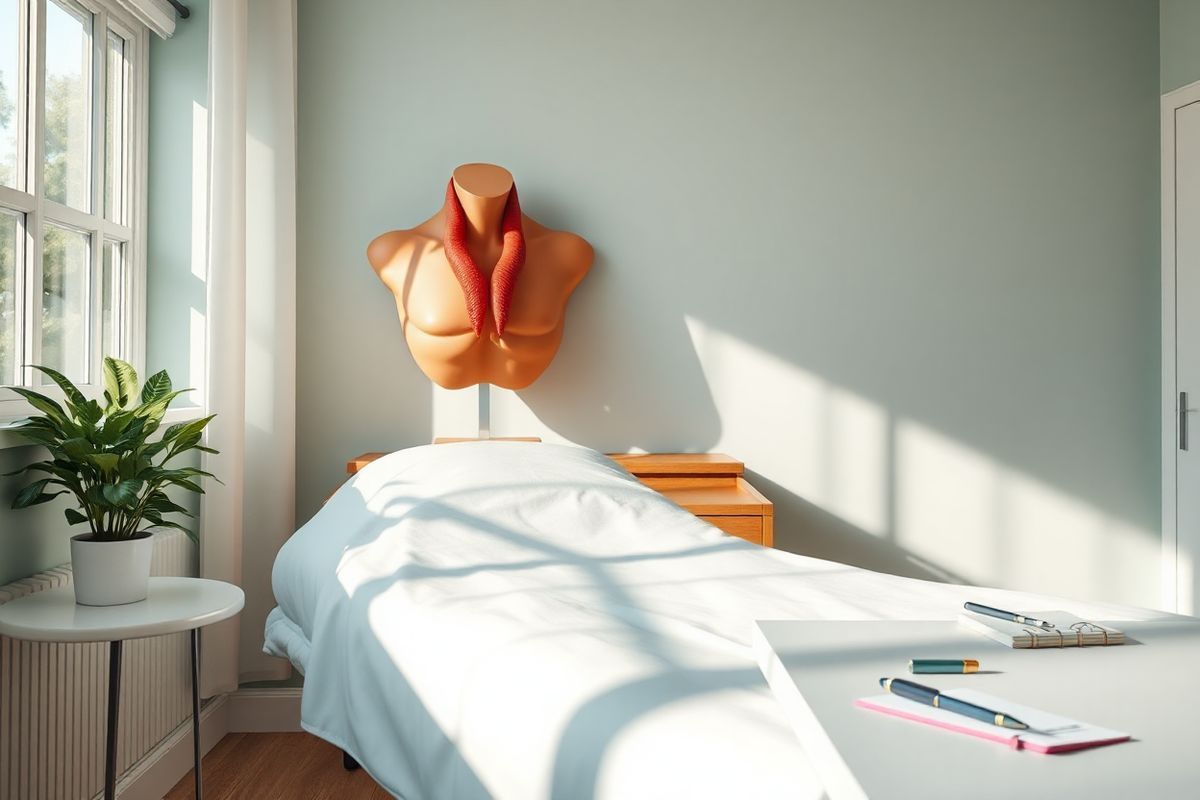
71, 534, 154, 606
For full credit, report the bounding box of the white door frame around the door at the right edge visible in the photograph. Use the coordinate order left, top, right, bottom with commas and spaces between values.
1160, 80, 1200, 613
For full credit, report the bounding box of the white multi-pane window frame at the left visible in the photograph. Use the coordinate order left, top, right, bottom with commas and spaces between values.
0, 0, 150, 426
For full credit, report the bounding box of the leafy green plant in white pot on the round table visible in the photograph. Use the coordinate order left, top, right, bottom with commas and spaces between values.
10, 357, 217, 606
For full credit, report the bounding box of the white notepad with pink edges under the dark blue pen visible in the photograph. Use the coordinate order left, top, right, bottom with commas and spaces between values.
854, 688, 1129, 753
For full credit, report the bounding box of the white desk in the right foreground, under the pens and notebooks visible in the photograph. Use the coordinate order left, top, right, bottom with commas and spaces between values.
755, 621, 1200, 800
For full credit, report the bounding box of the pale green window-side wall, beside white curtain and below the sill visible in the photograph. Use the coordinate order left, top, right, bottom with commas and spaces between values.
0, 0, 208, 585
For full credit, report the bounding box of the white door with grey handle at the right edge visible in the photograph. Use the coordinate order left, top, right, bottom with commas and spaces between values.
1163, 84, 1200, 614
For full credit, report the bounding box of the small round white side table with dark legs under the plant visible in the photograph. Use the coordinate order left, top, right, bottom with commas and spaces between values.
0, 578, 245, 800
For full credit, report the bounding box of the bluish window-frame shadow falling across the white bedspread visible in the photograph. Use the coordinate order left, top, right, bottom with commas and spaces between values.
310, 486, 755, 798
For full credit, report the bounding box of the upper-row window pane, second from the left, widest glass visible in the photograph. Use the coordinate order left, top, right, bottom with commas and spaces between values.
44, 0, 91, 211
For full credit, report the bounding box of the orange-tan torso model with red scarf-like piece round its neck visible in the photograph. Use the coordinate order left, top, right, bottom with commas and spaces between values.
367, 164, 593, 389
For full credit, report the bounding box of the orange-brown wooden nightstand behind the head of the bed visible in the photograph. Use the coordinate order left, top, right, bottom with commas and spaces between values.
346, 448, 775, 547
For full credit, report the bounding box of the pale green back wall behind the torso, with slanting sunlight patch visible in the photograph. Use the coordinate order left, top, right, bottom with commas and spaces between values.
298, 0, 1159, 604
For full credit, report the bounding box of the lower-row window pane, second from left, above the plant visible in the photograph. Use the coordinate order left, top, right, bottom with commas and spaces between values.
38, 223, 91, 383
